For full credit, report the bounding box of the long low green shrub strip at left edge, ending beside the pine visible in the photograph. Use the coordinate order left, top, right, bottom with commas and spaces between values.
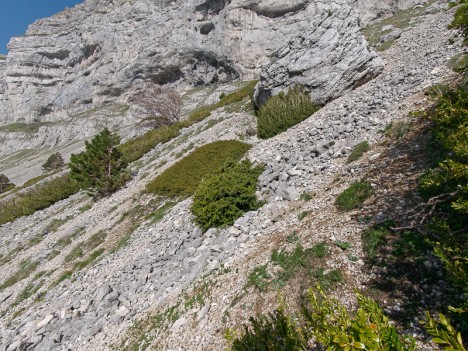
0, 174, 80, 224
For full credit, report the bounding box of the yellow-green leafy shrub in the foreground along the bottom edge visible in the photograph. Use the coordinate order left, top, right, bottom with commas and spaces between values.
229, 289, 415, 351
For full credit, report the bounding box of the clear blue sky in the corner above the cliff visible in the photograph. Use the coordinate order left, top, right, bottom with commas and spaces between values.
0, 0, 84, 54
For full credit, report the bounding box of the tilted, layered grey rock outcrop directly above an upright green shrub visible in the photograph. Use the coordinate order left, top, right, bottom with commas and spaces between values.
255, 1, 383, 105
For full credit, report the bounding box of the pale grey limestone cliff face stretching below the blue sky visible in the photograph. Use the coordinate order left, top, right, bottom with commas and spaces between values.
0, 0, 381, 124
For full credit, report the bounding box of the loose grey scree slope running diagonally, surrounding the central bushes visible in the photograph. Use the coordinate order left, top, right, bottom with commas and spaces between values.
0, 1, 460, 350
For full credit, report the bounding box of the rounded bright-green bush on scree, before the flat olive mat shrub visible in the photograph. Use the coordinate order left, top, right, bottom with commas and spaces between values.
191, 160, 263, 229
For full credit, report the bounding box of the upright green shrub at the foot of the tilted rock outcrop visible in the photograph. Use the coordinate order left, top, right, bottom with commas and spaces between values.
257, 85, 319, 139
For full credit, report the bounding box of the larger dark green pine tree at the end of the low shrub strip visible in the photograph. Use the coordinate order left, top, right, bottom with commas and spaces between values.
69, 128, 128, 196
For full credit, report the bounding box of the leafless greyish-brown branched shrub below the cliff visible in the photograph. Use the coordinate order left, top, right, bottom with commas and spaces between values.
136, 85, 182, 128
